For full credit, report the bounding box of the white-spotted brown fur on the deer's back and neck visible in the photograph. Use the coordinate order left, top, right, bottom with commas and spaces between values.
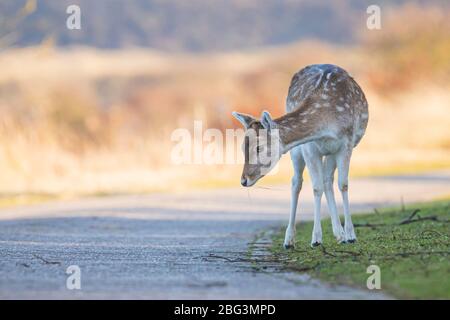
274, 65, 368, 146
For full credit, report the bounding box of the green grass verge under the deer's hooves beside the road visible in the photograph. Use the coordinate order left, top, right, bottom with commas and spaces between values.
272, 199, 450, 299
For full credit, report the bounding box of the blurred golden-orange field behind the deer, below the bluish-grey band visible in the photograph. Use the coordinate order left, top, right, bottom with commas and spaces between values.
0, 3, 450, 202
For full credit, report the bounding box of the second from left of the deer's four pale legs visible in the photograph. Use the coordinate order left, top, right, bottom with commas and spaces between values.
303, 145, 324, 247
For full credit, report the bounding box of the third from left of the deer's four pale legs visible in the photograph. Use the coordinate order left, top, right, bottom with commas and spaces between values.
323, 155, 345, 242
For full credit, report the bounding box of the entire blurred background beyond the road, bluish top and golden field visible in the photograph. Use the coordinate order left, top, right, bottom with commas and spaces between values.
0, 0, 450, 205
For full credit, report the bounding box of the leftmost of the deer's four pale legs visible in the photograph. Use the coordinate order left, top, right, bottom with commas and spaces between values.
284, 146, 305, 249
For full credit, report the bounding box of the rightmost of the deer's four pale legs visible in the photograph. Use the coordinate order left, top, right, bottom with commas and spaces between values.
336, 147, 356, 243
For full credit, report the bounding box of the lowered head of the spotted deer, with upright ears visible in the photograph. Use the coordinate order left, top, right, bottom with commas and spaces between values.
232, 111, 282, 187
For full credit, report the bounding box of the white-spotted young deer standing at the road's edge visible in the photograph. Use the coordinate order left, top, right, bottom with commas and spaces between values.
233, 64, 369, 248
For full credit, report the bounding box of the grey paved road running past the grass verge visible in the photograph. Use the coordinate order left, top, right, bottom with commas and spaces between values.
0, 172, 450, 299
